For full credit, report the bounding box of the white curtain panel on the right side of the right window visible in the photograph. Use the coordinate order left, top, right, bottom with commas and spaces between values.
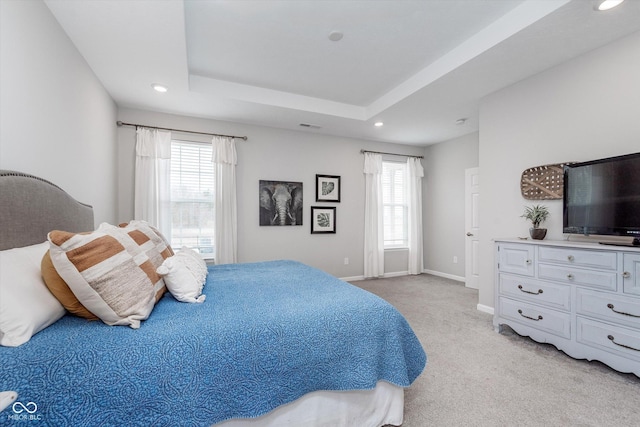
407, 157, 424, 274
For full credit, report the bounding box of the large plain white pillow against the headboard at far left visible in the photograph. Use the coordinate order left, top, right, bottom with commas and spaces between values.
0, 242, 65, 347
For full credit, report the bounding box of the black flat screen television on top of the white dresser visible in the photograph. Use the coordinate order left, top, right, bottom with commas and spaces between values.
563, 153, 640, 246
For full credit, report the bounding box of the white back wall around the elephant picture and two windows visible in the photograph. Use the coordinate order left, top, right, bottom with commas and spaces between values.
118, 109, 424, 278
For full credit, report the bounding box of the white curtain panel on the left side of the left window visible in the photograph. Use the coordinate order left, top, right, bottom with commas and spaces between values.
133, 127, 171, 238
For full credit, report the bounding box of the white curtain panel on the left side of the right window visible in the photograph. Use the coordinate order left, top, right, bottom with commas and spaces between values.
364, 153, 384, 277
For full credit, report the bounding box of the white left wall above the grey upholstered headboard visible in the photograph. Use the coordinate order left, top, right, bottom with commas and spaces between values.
0, 1, 116, 227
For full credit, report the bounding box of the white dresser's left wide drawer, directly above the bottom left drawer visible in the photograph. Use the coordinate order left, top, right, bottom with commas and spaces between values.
499, 274, 571, 310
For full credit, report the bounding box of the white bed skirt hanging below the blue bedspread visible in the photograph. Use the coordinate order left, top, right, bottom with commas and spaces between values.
216, 381, 404, 427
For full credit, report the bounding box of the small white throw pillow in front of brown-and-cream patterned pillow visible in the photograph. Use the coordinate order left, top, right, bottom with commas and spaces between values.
156, 247, 207, 302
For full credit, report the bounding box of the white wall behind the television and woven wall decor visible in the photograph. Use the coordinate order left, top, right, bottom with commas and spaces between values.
479, 32, 640, 307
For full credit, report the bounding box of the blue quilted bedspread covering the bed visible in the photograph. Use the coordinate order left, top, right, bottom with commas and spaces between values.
0, 261, 426, 426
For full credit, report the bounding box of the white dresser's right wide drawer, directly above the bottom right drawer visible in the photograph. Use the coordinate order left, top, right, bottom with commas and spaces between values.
576, 288, 640, 327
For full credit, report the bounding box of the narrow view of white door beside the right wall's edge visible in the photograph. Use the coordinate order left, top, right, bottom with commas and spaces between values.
464, 168, 480, 289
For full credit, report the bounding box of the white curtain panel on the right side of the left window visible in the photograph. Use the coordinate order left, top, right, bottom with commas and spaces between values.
212, 136, 238, 264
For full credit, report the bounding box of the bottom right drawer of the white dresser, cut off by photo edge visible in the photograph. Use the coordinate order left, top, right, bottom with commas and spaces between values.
576, 316, 640, 360
